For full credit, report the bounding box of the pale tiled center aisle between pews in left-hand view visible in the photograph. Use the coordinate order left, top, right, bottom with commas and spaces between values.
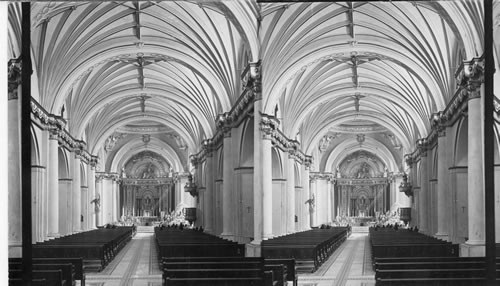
85, 227, 161, 286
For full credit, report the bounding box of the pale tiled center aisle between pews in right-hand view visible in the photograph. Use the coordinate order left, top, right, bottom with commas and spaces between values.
298, 228, 375, 286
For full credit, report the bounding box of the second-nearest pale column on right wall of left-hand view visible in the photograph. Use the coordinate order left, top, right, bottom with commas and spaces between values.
221, 128, 234, 240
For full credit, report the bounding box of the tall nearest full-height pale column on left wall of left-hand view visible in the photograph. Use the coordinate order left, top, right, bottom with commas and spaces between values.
47, 132, 60, 238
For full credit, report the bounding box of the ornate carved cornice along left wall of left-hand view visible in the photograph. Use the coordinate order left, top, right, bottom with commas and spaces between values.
31, 98, 98, 166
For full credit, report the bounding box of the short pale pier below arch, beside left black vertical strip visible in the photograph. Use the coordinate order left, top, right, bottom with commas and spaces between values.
31, 166, 48, 243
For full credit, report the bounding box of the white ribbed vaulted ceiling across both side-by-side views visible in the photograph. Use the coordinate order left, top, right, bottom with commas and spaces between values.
9, 0, 500, 171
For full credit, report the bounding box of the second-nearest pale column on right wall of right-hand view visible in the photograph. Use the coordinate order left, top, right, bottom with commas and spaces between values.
435, 127, 450, 240
